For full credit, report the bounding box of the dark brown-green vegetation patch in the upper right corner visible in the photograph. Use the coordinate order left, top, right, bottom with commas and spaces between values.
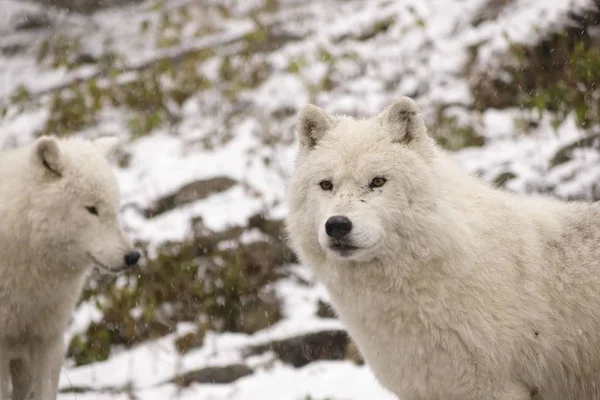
472, 3, 600, 129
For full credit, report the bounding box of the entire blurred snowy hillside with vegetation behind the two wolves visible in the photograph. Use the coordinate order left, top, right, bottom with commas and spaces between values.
0, 0, 600, 400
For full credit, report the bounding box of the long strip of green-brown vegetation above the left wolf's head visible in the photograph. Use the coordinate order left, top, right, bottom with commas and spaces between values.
32, 41, 212, 138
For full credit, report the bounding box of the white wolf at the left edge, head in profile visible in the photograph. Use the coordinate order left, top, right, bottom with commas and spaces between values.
0, 137, 140, 400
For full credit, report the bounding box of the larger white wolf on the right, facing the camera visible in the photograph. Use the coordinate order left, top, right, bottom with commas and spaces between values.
287, 97, 600, 400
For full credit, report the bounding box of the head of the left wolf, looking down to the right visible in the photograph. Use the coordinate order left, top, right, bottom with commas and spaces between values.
25, 136, 140, 272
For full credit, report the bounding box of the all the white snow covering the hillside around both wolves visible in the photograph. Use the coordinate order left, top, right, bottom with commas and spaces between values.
0, 0, 600, 400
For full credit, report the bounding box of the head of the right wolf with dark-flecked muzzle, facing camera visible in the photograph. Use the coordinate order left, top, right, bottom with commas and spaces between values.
286, 97, 437, 263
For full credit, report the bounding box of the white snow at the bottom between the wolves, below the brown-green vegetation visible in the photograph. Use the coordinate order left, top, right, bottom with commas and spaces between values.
59, 265, 354, 400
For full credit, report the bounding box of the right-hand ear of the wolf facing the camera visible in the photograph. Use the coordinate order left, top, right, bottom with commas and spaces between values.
383, 96, 427, 144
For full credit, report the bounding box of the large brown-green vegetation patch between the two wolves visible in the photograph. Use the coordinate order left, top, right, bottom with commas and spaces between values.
67, 216, 292, 365
